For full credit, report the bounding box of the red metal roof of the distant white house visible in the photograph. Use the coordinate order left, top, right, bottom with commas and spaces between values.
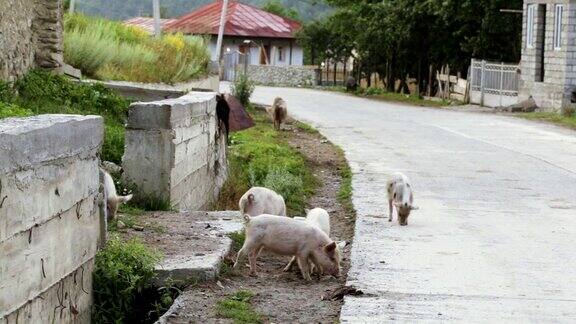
165, 0, 300, 38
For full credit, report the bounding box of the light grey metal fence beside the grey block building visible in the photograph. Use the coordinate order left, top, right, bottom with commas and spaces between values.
469, 59, 520, 107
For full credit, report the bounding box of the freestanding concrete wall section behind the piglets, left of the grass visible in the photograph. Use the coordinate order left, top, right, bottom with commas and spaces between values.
122, 92, 227, 211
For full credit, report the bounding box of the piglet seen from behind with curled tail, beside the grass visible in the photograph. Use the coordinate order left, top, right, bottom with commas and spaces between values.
238, 187, 286, 216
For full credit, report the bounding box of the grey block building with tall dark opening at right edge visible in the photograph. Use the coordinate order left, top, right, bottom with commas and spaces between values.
519, 0, 576, 110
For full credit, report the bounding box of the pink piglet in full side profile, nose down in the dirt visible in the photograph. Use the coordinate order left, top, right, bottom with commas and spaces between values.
234, 214, 340, 281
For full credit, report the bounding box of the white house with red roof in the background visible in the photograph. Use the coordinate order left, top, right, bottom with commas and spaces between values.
165, 0, 304, 66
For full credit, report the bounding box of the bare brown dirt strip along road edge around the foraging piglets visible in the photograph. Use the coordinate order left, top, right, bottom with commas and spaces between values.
162, 119, 354, 323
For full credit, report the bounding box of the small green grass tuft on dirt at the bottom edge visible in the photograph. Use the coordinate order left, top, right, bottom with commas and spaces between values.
216, 290, 263, 324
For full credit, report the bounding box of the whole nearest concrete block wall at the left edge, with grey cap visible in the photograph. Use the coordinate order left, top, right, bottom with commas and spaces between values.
0, 115, 103, 323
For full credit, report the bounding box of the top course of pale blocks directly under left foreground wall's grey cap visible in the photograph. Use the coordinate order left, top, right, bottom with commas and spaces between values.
0, 157, 99, 242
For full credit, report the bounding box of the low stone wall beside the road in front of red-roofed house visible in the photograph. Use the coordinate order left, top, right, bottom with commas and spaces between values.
241, 65, 316, 87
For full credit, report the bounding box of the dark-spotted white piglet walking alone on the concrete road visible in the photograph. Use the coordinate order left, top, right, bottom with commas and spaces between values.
386, 172, 418, 226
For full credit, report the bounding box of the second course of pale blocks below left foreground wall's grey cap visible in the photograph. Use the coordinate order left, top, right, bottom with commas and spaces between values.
0, 196, 100, 317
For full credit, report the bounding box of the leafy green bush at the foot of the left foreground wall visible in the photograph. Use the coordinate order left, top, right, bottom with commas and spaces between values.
92, 237, 160, 323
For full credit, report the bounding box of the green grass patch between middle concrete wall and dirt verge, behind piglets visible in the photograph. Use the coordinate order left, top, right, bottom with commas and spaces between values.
214, 104, 318, 215
